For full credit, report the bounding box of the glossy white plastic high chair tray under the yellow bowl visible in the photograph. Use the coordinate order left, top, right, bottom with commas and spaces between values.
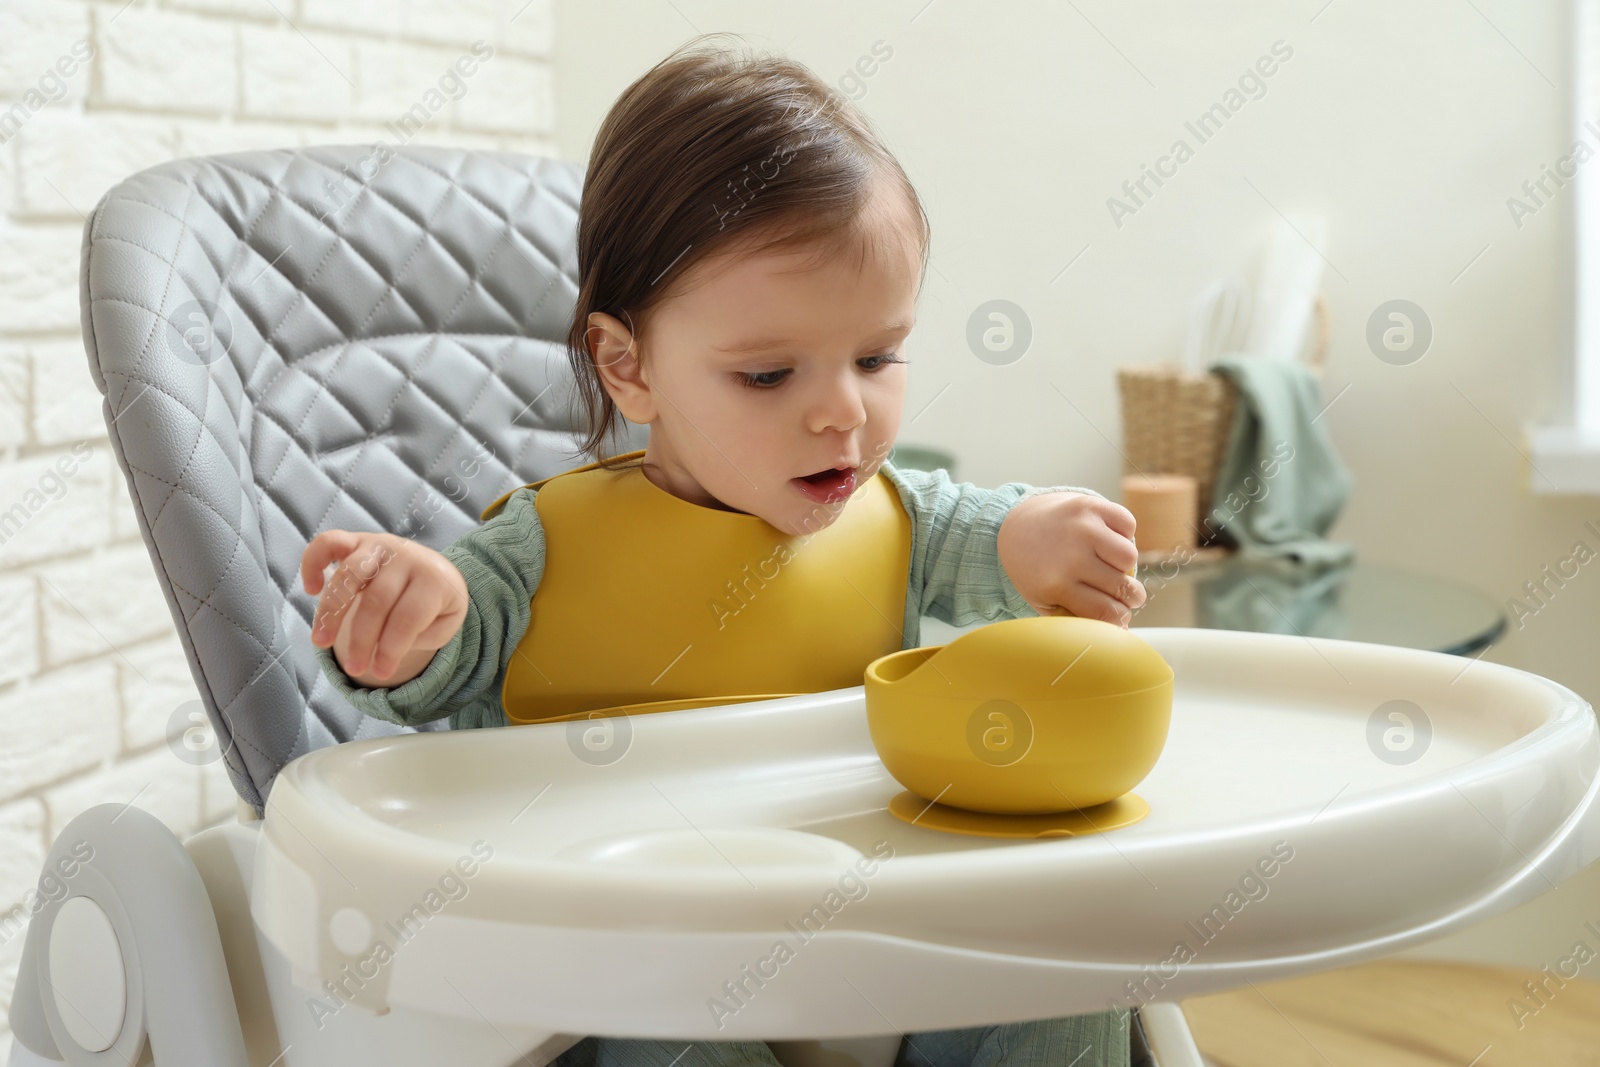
251, 629, 1600, 1040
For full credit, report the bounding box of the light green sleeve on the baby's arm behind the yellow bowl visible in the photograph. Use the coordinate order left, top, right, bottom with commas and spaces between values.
883, 462, 1101, 633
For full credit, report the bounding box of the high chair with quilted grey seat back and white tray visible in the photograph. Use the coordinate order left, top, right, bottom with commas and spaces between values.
10, 146, 1600, 1067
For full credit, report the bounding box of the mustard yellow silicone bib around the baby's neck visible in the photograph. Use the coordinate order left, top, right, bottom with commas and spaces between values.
483, 450, 910, 723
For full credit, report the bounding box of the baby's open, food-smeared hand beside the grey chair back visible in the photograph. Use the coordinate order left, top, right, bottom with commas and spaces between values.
301, 530, 467, 683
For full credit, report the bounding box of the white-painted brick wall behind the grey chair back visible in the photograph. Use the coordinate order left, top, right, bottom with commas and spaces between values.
0, 0, 557, 1062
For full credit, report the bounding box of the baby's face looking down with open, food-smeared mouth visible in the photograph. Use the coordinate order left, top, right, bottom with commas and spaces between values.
613, 198, 922, 534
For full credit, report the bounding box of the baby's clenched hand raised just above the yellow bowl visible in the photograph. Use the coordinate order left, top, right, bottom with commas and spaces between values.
995, 493, 1146, 627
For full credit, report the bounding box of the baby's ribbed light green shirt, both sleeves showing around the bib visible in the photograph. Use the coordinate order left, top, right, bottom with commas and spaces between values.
315, 462, 1099, 729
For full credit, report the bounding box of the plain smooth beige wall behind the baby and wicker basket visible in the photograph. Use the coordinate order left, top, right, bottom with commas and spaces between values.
555, 0, 1600, 966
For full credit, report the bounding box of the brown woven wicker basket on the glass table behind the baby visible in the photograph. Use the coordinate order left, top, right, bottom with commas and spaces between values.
1117, 296, 1328, 544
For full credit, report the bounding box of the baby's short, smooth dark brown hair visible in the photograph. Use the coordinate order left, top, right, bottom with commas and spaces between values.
566, 34, 931, 466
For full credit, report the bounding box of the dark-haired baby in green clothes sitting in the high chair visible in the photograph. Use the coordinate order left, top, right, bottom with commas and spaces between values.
301, 33, 1146, 1067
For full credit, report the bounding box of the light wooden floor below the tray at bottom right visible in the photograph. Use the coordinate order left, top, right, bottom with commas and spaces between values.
1182, 957, 1600, 1067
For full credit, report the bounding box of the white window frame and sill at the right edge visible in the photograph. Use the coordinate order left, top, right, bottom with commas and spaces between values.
1528, 0, 1600, 494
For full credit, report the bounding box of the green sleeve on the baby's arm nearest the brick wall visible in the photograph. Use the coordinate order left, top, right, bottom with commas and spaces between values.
308, 486, 544, 729
